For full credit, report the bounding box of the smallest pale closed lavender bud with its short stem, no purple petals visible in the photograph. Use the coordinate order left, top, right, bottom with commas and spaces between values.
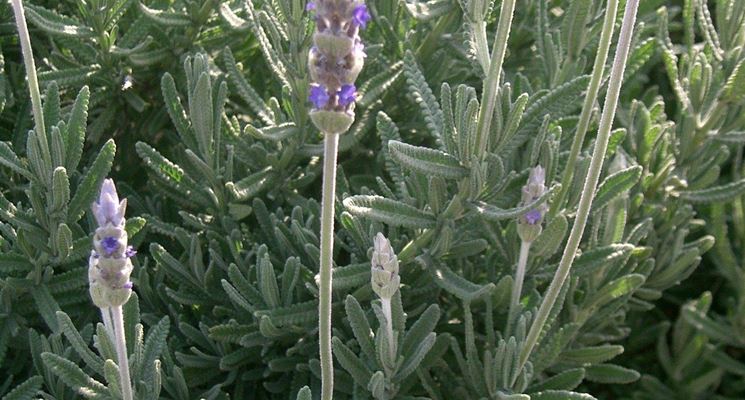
370, 232, 401, 358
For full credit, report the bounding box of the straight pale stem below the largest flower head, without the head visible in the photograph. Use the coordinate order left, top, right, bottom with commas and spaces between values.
318, 133, 339, 400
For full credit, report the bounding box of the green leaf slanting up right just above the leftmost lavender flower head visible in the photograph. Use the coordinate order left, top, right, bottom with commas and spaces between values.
67, 139, 116, 222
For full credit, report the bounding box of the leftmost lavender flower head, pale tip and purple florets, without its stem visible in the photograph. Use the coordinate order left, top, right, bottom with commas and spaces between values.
88, 179, 136, 308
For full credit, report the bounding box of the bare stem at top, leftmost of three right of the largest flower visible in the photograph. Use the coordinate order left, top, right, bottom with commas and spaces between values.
475, 0, 515, 159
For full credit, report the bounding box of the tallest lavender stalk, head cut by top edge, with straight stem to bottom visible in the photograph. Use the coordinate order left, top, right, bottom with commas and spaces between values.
307, 0, 370, 400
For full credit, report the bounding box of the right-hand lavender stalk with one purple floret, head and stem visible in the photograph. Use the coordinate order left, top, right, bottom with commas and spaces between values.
506, 165, 548, 335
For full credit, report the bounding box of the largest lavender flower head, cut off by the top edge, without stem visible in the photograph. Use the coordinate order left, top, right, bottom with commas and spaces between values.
306, 0, 371, 133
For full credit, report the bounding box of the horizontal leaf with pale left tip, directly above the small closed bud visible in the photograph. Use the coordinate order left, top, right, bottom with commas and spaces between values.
344, 195, 436, 229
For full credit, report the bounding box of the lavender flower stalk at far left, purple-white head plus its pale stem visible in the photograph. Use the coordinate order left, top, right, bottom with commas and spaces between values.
88, 179, 135, 400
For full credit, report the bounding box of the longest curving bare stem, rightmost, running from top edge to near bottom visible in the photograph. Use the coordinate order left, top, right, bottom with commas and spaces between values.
513, 0, 639, 384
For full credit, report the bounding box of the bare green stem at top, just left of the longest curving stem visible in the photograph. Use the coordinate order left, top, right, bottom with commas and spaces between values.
550, 0, 618, 217
